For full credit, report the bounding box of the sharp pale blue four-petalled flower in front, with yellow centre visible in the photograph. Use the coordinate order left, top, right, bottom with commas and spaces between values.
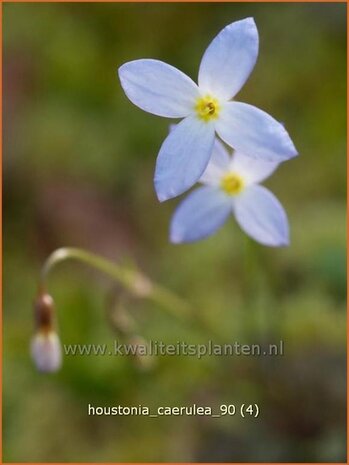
119, 18, 297, 201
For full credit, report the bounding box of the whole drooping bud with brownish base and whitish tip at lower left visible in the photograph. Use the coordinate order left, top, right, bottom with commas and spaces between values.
31, 292, 62, 372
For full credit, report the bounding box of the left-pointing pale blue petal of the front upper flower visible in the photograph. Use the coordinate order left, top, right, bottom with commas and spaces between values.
119, 59, 199, 118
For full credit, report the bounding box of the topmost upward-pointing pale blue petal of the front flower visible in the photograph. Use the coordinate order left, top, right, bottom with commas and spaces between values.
199, 18, 258, 100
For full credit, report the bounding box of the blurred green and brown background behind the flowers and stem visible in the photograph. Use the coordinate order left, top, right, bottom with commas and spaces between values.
3, 3, 346, 462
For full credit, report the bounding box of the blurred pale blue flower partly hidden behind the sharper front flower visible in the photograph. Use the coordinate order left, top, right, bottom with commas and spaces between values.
170, 139, 289, 247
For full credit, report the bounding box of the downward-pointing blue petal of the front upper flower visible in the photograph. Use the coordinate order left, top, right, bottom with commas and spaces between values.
154, 116, 214, 202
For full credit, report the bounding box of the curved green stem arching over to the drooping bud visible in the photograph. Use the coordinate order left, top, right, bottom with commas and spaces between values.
40, 247, 192, 318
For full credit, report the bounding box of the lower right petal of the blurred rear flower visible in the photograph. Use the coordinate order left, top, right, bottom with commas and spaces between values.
234, 185, 289, 247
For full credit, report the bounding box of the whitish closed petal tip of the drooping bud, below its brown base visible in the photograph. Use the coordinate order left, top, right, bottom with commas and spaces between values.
31, 331, 62, 372
